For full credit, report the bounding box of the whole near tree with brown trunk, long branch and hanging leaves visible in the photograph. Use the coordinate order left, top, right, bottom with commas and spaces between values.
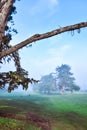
0, 0, 87, 91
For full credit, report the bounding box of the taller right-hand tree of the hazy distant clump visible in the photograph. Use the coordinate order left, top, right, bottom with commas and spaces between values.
56, 64, 80, 91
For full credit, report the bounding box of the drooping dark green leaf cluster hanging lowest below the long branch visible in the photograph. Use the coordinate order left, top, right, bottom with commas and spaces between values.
0, 69, 37, 92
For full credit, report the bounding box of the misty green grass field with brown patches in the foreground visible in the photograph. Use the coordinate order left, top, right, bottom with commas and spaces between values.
0, 94, 87, 130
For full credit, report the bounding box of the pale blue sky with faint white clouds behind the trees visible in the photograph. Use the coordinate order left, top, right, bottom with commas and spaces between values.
2, 0, 87, 89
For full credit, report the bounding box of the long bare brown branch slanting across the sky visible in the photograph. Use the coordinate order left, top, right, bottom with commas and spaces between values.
0, 22, 87, 58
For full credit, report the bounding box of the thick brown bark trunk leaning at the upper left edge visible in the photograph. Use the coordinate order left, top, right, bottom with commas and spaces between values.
0, 0, 14, 48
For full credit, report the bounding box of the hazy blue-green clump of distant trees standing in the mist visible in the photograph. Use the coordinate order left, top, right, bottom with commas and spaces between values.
34, 64, 80, 94
